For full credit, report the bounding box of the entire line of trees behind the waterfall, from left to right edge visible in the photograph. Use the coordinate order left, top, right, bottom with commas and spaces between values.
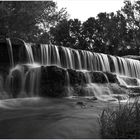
0, 0, 140, 56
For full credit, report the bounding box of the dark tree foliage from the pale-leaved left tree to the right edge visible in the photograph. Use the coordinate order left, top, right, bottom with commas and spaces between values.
50, 1, 140, 55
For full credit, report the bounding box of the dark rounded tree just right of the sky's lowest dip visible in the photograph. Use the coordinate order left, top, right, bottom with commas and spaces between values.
82, 11, 127, 55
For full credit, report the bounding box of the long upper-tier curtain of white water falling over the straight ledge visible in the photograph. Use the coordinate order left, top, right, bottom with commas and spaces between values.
15, 43, 140, 79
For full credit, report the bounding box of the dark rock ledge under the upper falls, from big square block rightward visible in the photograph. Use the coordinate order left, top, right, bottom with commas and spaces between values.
39, 66, 120, 97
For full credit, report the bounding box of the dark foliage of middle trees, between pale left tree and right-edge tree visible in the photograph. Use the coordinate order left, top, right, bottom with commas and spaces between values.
50, 12, 127, 54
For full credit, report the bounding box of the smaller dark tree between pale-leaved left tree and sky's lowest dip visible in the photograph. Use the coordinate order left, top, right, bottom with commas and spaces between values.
50, 19, 82, 49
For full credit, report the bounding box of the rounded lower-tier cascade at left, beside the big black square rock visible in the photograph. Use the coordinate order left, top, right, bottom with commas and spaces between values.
6, 64, 41, 97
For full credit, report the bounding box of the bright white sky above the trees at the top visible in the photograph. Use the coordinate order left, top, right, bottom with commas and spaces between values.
54, 0, 130, 21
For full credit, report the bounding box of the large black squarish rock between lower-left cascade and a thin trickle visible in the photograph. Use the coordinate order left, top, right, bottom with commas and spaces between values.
39, 66, 67, 97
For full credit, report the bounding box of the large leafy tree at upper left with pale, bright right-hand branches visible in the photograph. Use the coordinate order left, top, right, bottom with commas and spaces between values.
0, 1, 67, 42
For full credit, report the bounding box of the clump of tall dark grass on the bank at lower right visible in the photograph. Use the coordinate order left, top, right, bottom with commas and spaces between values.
99, 99, 140, 139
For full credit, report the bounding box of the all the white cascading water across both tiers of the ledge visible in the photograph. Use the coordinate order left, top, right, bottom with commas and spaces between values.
2, 39, 140, 100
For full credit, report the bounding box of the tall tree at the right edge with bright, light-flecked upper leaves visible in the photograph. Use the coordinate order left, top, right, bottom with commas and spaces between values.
121, 0, 140, 55
